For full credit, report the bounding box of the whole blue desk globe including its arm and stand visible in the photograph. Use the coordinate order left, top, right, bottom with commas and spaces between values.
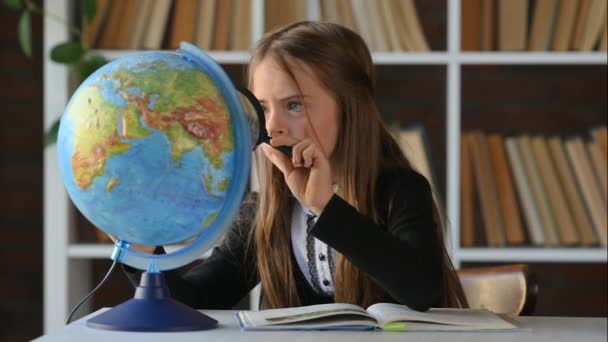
57, 43, 268, 331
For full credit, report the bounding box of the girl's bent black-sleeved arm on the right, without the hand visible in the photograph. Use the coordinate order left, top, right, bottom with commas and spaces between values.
311, 170, 443, 311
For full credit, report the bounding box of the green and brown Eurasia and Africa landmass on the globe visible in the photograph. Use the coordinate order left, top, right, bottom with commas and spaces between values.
67, 61, 234, 193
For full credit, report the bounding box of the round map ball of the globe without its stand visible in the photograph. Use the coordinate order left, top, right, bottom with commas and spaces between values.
57, 52, 240, 245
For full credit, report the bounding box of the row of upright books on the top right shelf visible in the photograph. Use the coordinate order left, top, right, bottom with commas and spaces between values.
462, 0, 608, 51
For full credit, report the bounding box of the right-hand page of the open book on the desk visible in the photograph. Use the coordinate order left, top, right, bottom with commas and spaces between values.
367, 303, 515, 330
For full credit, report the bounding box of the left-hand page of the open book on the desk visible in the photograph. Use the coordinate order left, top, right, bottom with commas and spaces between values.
237, 304, 377, 327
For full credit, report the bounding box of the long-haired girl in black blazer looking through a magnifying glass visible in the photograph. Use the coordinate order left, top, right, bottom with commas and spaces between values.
126, 22, 466, 310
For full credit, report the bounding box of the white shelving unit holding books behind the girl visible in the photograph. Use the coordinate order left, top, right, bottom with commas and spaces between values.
44, 0, 608, 334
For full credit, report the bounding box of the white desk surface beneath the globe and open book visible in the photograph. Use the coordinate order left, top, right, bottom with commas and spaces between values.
36, 309, 607, 342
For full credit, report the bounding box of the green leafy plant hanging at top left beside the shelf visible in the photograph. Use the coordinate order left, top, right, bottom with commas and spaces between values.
3, 0, 108, 146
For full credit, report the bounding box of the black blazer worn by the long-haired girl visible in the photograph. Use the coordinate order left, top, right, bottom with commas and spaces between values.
125, 169, 443, 310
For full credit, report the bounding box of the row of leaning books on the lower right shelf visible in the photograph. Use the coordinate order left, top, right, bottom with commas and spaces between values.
460, 126, 608, 247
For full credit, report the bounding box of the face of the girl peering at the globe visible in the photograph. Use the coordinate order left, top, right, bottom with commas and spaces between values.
252, 58, 338, 158
